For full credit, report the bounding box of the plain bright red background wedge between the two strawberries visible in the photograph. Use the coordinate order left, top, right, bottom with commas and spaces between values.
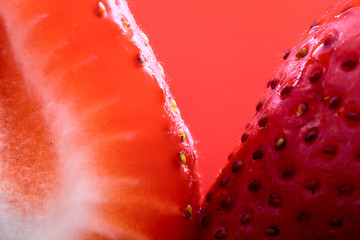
128, 0, 336, 200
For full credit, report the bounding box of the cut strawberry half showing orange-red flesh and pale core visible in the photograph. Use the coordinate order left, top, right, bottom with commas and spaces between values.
0, 0, 199, 240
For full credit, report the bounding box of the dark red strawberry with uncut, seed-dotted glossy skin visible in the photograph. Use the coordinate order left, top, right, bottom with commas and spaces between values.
200, 1, 360, 240
